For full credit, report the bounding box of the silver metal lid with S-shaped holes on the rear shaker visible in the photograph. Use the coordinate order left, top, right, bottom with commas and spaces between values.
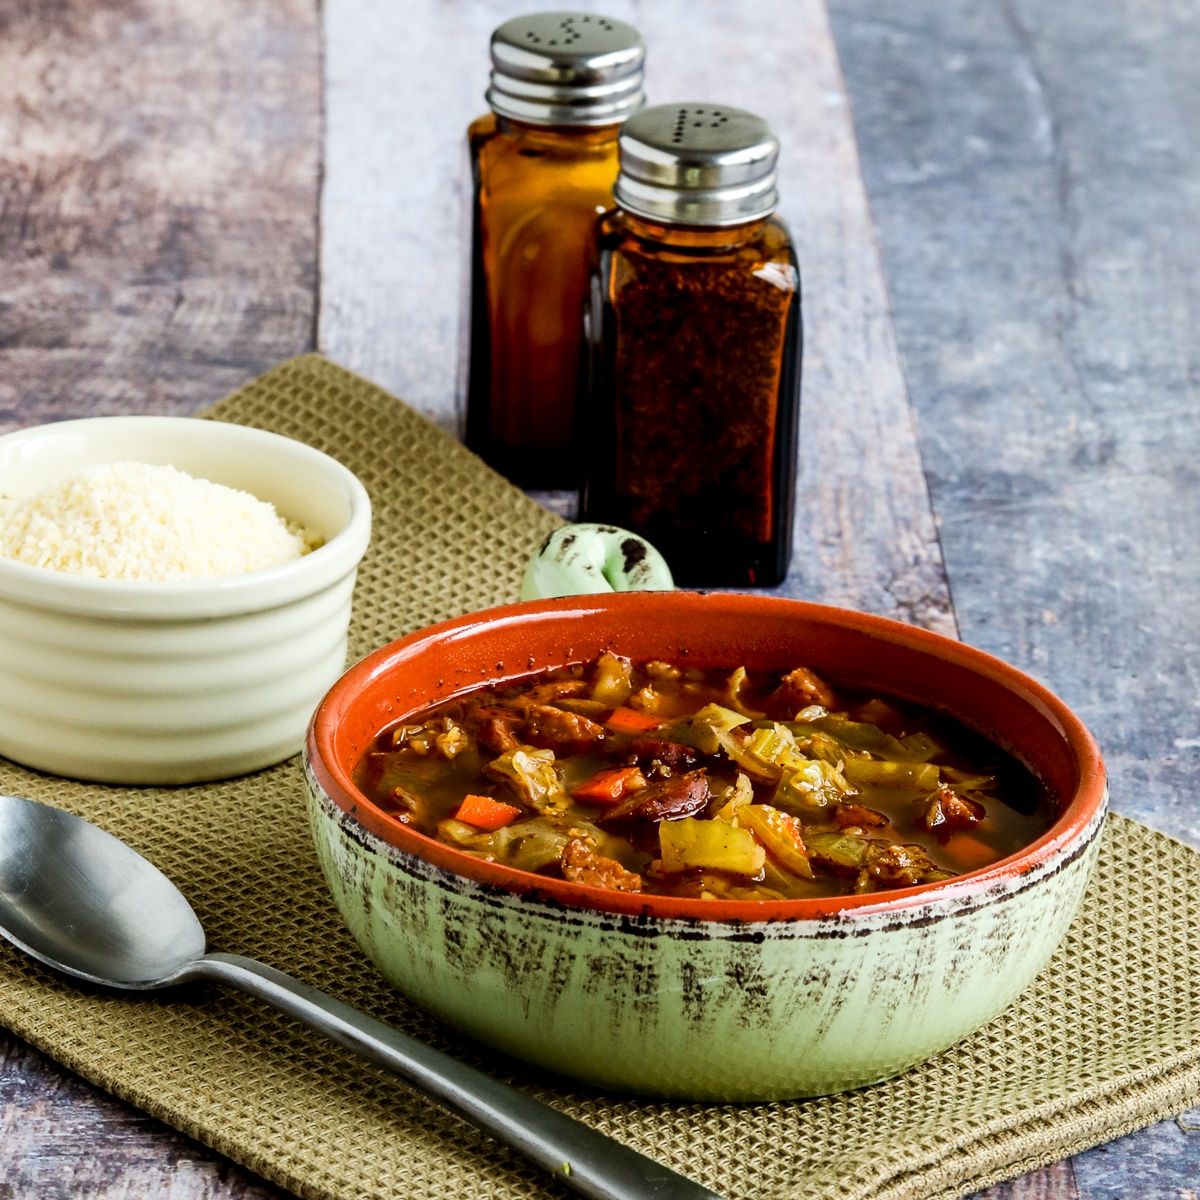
487, 12, 646, 125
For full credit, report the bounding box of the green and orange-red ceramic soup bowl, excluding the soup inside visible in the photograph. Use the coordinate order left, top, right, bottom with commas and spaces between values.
306, 592, 1106, 1100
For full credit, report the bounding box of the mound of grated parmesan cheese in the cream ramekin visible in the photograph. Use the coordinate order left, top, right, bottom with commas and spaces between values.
0, 462, 322, 580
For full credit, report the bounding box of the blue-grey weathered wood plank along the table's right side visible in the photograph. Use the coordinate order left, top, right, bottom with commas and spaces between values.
830, 0, 1200, 1200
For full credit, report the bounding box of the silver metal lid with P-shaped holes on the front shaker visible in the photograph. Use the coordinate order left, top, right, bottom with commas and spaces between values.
613, 103, 779, 226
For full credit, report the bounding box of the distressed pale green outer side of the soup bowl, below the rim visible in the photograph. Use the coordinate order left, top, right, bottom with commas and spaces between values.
308, 773, 1102, 1100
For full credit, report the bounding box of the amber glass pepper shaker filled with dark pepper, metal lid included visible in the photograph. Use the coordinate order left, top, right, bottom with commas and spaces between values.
582, 104, 802, 587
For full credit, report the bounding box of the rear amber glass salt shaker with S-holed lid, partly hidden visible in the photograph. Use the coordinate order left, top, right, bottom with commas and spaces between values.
467, 12, 644, 488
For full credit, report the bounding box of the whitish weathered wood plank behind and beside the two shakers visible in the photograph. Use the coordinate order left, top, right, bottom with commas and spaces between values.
319, 0, 955, 634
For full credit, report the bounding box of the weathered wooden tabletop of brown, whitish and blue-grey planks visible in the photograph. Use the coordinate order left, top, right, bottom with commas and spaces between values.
0, 0, 1200, 1200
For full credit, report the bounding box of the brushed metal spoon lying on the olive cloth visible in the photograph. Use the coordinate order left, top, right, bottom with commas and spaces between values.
0, 796, 721, 1200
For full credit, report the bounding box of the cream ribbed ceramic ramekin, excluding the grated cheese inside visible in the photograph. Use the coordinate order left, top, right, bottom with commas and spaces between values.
0, 416, 371, 784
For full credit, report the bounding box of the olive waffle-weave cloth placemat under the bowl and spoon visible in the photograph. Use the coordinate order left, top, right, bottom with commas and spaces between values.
0, 355, 1200, 1200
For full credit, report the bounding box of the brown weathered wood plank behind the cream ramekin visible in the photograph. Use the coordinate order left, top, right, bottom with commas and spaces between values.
0, 0, 320, 430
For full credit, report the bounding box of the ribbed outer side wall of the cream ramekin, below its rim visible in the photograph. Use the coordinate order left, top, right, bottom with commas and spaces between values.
0, 570, 355, 784
